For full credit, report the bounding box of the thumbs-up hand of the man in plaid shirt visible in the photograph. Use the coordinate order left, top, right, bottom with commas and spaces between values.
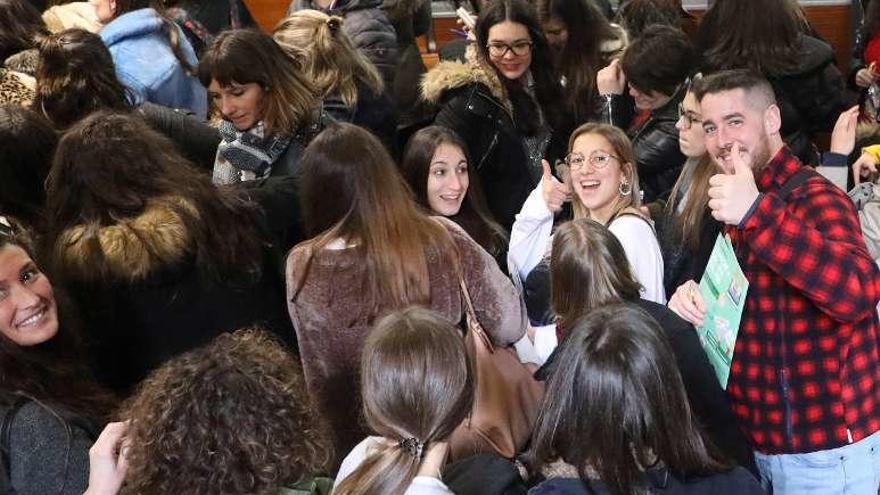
709, 145, 759, 225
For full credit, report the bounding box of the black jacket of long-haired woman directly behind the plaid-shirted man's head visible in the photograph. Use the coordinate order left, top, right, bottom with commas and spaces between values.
768, 35, 854, 165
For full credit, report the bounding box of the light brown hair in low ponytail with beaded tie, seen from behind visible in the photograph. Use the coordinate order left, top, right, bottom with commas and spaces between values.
333, 307, 474, 495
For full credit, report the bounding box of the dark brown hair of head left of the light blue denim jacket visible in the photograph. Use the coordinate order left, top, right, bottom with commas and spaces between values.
32, 29, 131, 129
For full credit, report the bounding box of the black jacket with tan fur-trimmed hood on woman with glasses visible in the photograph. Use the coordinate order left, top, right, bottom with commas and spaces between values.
422, 62, 568, 232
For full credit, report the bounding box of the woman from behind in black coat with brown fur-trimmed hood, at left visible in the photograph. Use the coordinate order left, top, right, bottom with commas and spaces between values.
44, 111, 296, 394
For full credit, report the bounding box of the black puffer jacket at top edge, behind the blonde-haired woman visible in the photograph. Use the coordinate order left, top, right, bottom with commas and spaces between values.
287, 0, 397, 88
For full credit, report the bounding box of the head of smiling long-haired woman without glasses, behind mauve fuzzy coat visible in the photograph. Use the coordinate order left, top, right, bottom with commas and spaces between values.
400, 125, 507, 267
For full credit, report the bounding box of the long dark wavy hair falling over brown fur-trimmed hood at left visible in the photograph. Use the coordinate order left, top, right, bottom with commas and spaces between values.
45, 111, 263, 283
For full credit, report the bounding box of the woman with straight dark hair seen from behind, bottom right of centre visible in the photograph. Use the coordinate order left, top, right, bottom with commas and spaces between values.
528, 304, 764, 495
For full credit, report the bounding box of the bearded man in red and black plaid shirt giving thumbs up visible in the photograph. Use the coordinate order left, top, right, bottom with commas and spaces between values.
669, 71, 880, 495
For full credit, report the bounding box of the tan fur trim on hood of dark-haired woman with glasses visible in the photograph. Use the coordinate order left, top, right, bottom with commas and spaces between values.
422, 61, 511, 109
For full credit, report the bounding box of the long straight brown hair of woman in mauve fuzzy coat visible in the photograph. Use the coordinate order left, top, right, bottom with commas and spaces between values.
293, 123, 456, 311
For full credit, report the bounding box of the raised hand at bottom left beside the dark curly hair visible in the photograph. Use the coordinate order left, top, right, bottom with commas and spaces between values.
83, 422, 128, 495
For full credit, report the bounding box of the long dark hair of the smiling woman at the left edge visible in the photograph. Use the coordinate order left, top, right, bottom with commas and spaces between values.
0, 217, 116, 423
